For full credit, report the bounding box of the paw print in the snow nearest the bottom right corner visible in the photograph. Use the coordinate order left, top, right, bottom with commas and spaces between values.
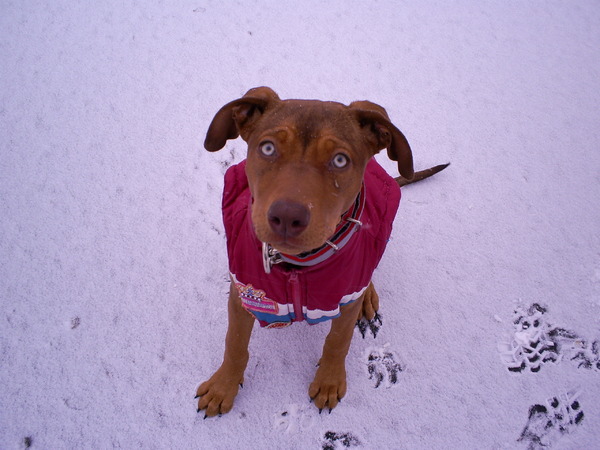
517, 391, 584, 450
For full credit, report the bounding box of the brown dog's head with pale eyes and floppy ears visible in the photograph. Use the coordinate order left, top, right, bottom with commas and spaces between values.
204, 87, 414, 254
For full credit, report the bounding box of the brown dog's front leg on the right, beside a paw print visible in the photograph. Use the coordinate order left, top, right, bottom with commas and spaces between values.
308, 295, 364, 412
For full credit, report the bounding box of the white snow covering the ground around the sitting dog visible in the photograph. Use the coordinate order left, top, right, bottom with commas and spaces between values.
0, 0, 600, 449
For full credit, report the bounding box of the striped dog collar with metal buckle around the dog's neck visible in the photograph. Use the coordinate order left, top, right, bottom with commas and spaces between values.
262, 183, 366, 273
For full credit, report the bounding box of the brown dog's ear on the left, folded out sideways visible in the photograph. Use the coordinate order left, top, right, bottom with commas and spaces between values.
204, 87, 280, 152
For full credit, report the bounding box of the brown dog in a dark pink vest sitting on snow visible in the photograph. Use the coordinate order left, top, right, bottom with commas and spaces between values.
196, 87, 446, 418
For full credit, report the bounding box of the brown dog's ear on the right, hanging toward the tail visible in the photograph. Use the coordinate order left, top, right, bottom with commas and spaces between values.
350, 101, 415, 180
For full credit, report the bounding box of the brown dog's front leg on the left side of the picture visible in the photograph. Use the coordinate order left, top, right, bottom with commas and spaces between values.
196, 280, 254, 418
